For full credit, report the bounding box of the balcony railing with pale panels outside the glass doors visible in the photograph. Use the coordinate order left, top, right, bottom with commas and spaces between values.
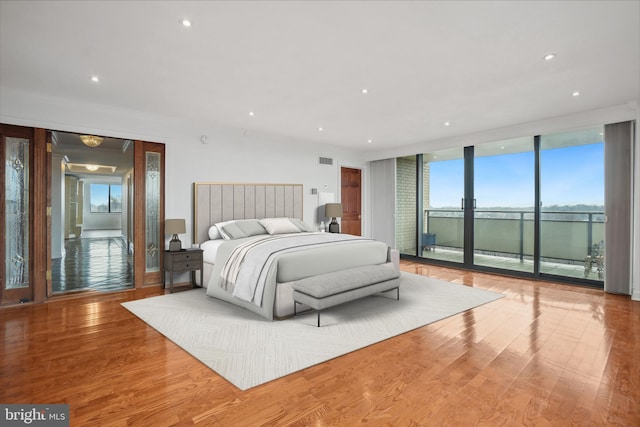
424, 209, 604, 264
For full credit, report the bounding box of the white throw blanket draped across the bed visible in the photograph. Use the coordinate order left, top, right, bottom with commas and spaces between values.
218, 233, 371, 306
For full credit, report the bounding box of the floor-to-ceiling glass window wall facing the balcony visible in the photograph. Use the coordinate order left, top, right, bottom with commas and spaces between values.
396, 127, 605, 285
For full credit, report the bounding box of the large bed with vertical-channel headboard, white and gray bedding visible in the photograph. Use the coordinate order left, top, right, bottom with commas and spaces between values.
193, 183, 393, 320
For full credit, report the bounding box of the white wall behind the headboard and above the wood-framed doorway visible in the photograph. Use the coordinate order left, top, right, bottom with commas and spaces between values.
0, 88, 368, 246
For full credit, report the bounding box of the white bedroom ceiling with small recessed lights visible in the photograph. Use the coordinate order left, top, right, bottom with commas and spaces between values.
0, 1, 640, 151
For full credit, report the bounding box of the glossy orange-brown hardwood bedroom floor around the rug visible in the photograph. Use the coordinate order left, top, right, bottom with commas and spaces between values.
0, 262, 640, 426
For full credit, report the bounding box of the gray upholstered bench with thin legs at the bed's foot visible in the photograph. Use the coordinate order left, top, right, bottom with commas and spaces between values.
292, 263, 400, 327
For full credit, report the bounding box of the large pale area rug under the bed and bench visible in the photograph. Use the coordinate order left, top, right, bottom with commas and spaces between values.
122, 272, 503, 390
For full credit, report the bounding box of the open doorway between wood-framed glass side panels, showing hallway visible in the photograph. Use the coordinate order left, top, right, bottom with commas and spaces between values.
49, 132, 134, 295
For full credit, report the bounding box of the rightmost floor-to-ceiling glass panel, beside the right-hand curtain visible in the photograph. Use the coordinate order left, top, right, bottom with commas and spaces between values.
540, 127, 605, 280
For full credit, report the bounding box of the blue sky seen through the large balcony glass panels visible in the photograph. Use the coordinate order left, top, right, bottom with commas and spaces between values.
430, 143, 604, 209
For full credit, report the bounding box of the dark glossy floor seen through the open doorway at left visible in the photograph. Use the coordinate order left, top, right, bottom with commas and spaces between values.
52, 232, 133, 294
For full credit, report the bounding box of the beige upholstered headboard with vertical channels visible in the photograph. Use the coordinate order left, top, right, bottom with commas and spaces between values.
193, 182, 303, 243
